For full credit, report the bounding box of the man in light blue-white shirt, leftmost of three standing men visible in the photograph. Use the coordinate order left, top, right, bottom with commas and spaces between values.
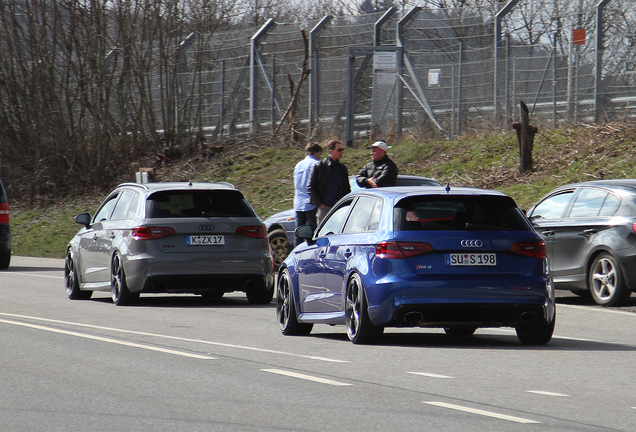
294, 142, 322, 244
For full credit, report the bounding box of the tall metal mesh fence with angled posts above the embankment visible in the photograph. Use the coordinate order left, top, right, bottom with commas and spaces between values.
124, 0, 636, 144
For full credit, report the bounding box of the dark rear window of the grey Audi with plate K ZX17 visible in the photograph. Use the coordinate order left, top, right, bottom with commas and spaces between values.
146, 190, 255, 218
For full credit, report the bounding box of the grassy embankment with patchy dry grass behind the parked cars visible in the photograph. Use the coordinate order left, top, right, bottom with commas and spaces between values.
9, 123, 636, 258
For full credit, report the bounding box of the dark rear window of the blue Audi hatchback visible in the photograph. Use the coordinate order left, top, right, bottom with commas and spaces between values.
394, 196, 532, 231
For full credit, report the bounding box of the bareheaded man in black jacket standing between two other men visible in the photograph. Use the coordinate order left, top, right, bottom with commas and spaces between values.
307, 140, 351, 222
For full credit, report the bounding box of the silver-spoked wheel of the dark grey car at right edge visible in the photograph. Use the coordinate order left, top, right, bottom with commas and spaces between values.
587, 252, 631, 306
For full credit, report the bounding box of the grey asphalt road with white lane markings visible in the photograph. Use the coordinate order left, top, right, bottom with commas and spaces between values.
0, 257, 636, 432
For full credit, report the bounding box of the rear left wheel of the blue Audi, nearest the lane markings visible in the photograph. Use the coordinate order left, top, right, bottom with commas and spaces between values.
345, 273, 384, 345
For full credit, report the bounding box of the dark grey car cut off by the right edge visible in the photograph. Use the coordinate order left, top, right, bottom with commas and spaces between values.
528, 179, 636, 306
